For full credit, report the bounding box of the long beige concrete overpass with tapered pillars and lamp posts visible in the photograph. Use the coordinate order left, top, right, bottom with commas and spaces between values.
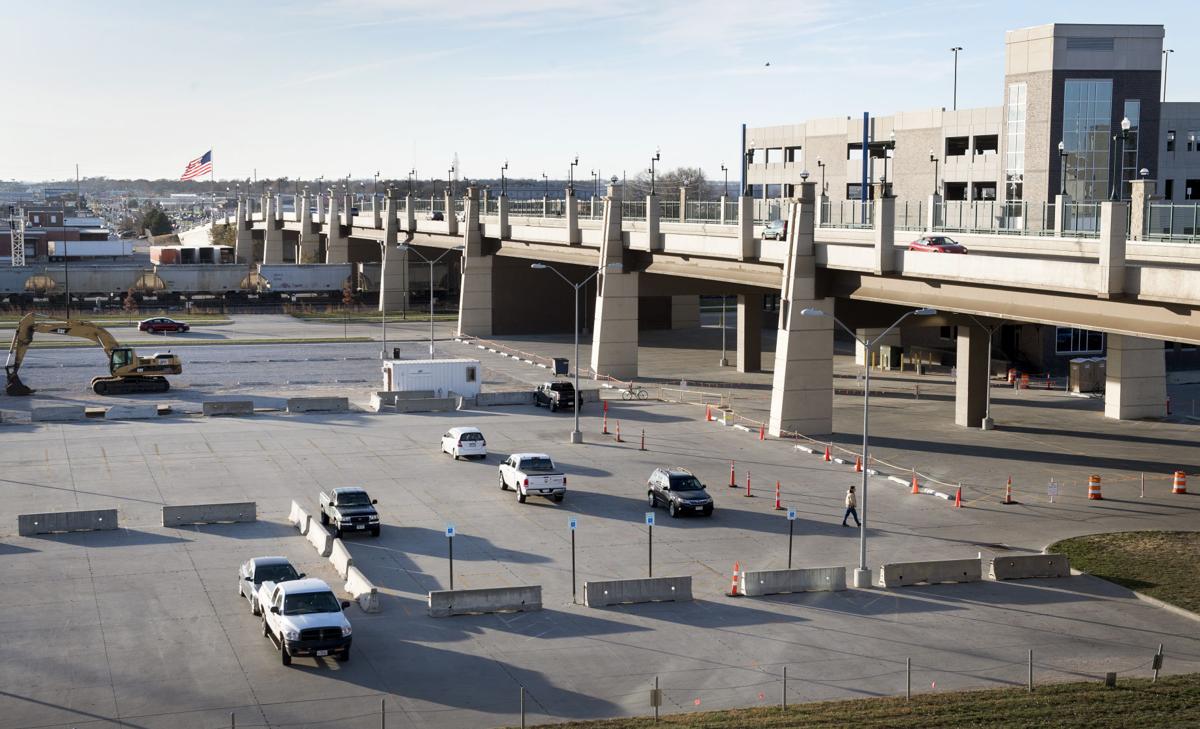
220, 183, 1200, 435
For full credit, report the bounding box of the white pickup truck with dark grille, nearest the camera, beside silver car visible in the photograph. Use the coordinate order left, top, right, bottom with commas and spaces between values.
258, 578, 353, 665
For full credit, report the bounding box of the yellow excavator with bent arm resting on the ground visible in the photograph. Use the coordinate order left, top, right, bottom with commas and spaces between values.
4, 314, 184, 396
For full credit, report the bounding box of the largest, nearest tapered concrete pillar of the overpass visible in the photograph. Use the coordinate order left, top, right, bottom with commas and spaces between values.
767, 182, 834, 436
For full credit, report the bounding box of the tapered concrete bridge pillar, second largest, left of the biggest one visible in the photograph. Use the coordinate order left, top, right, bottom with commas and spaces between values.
592, 185, 649, 380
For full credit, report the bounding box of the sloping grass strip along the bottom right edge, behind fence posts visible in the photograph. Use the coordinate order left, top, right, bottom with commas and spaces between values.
520, 674, 1200, 729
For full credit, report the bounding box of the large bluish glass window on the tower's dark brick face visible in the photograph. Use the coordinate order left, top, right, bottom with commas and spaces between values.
1062, 78, 1112, 201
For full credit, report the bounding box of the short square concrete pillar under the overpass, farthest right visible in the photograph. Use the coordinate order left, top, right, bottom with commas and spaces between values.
1104, 335, 1166, 420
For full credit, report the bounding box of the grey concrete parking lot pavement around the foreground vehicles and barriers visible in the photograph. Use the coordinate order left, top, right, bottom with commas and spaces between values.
7, 403, 1200, 729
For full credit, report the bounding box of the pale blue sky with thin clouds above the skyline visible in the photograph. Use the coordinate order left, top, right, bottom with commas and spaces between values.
0, 0, 1200, 181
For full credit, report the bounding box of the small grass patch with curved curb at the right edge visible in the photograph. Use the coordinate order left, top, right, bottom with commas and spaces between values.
1050, 529, 1200, 613
